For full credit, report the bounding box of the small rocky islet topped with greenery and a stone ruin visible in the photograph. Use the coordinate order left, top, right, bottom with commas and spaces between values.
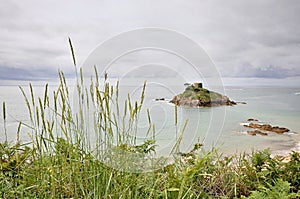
170, 83, 236, 107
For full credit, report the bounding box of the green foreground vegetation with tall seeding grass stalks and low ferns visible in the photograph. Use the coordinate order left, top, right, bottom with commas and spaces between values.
0, 41, 300, 198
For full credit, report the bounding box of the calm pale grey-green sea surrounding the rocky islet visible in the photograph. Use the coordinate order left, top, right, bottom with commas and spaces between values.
0, 83, 300, 154
